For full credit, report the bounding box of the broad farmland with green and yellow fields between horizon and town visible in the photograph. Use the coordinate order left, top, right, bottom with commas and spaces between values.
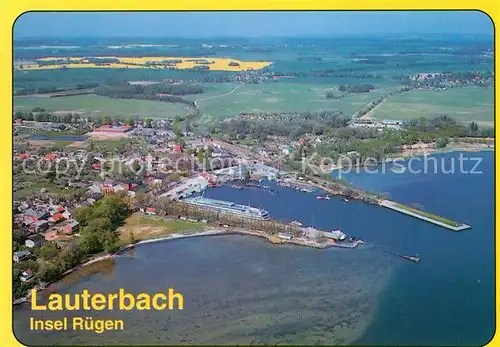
14, 37, 493, 125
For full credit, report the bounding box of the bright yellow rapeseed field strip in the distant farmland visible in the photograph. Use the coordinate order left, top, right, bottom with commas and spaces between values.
16, 57, 272, 71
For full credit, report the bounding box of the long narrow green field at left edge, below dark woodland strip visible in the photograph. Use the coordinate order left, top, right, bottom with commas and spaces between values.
14, 95, 189, 119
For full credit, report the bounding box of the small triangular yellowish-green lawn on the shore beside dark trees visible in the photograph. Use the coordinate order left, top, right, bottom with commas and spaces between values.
118, 212, 205, 245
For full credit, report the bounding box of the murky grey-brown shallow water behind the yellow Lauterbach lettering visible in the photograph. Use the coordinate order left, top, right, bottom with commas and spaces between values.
16, 235, 394, 344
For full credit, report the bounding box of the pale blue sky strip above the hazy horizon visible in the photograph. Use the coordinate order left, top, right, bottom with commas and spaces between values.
14, 11, 493, 39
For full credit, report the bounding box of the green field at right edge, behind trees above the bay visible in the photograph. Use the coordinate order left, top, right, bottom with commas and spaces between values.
372, 86, 494, 125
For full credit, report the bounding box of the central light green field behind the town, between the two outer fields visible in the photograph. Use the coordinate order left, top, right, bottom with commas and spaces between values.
193, 82, 398, 123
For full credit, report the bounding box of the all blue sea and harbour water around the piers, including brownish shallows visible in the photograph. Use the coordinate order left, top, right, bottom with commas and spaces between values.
15, 152, 495, 346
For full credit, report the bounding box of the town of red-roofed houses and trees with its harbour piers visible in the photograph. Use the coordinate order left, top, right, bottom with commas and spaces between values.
13, 83, 491, 304
